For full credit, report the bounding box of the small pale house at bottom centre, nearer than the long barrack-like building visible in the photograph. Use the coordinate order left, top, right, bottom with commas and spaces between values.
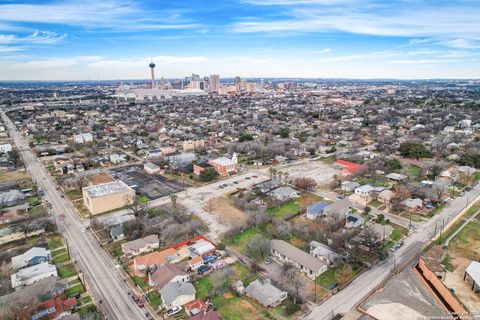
244, 279, 287, 308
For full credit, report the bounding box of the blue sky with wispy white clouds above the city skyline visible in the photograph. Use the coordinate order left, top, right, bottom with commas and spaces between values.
0, 0, 480, 80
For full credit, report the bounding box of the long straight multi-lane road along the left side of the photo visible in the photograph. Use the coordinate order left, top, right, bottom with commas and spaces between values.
2, 112, 146, 319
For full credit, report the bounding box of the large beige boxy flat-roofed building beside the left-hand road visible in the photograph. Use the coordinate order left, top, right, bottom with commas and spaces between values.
83, 180, 135, 214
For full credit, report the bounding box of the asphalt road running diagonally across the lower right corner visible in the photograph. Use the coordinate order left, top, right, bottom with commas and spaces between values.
304, 184, 480, 320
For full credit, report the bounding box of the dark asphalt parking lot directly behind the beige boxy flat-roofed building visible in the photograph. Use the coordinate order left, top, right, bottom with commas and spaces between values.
110, 165, 190, 200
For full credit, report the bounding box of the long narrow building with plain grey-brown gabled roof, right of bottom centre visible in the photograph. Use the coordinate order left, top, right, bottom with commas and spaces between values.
270, 239, 327, 279
